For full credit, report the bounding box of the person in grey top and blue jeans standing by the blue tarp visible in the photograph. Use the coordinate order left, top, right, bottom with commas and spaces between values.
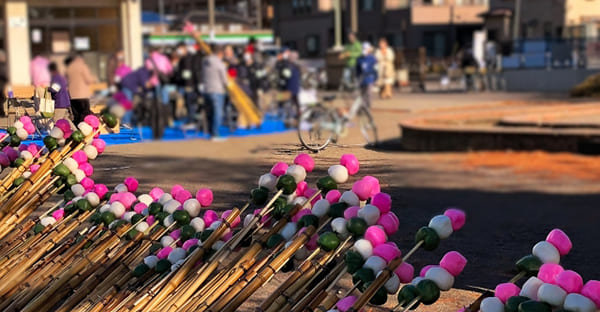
202, 46, 228, 140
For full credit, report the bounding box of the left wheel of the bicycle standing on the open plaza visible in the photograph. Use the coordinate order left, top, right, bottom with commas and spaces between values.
298, 105, 335, 152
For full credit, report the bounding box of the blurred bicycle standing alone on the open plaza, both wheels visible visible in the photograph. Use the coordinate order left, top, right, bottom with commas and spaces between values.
298, 87, 377, 152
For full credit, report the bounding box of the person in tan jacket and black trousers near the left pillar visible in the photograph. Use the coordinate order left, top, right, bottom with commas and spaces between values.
65, 53, 98, 125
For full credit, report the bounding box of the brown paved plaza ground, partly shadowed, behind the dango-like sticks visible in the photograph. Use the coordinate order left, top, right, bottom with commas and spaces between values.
90, 93, 600, 311
